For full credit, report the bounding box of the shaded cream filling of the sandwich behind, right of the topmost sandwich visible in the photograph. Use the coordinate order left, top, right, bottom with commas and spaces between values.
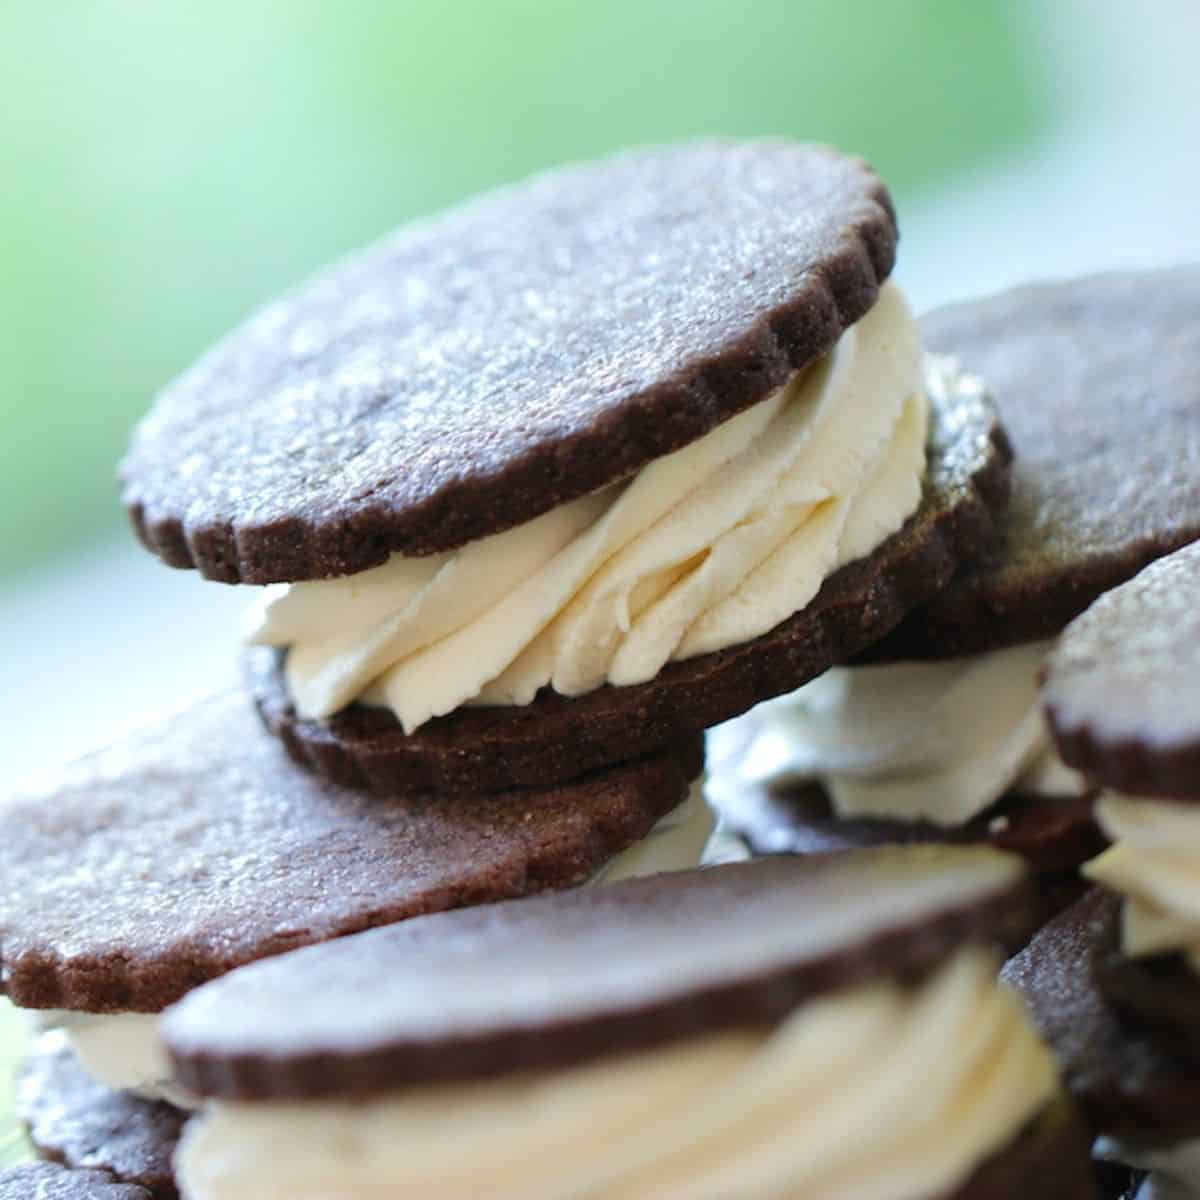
742, 642, 1086, 826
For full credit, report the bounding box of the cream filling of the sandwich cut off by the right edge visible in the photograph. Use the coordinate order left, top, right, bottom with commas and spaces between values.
1084, 793, 1200, 971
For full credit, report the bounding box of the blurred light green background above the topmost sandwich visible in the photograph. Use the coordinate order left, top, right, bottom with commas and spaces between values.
0, 0, 1049, 572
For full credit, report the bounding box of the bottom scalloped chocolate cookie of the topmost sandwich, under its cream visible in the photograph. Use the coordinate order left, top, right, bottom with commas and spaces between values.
247, 367, 1009, 794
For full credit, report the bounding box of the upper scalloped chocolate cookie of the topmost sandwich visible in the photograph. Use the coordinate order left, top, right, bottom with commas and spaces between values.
121, 140, 896, 583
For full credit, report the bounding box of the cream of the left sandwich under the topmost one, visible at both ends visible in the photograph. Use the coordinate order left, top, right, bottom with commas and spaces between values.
36, 780, 720, 1109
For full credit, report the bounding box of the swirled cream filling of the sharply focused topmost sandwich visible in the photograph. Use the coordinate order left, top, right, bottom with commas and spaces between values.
248, 284, 926, 732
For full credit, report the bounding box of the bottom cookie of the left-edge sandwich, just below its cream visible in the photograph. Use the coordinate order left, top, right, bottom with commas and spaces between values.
17, 1033, 187, 1200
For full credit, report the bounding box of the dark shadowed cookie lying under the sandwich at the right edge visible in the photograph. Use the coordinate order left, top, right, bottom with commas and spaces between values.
1002, 888, 1200, 1142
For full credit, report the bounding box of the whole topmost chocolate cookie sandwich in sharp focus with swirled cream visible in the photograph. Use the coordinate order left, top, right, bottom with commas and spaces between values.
122, 140, 1008, 794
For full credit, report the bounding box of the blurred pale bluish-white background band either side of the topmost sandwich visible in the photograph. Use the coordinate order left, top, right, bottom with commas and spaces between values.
0, 0, 1200, 790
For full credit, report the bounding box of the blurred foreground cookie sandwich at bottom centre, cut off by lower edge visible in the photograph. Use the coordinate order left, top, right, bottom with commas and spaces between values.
164, 847, 1093, 1200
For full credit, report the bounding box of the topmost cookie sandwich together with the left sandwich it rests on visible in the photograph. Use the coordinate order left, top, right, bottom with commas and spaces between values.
0, 142, 1012, 1198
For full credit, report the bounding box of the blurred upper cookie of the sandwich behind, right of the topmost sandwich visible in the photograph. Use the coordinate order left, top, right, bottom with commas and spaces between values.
871, 266, 1200, 661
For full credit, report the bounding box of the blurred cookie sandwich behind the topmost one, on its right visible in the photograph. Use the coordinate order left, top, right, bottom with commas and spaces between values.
714, 260, 1200, 894
